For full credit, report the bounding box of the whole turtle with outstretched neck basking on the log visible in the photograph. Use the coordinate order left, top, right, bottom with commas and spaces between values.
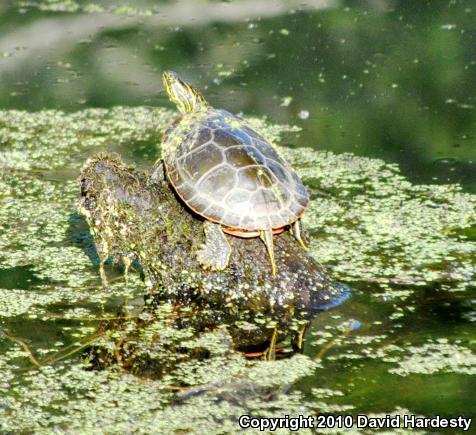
159, 71, 309, 275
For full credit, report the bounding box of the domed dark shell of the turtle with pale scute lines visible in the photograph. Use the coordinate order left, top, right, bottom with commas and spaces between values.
162, 108, 309, 231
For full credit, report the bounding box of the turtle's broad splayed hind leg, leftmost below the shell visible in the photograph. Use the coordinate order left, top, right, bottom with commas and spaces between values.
197, 221, 231, 270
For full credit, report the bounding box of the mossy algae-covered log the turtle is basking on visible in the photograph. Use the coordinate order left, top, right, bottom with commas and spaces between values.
80, 154, 342, 345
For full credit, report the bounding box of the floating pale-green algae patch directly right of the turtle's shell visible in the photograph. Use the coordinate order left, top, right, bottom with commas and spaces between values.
282, 149, 476, 285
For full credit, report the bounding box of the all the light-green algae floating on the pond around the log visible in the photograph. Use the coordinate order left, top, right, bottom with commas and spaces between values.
0, 107, 476, 433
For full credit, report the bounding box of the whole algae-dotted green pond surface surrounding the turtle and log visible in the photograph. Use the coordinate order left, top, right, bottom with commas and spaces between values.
0, 0, 476, 433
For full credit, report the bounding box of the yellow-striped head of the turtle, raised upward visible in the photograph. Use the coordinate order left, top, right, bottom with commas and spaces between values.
162, 71, 207, 113
